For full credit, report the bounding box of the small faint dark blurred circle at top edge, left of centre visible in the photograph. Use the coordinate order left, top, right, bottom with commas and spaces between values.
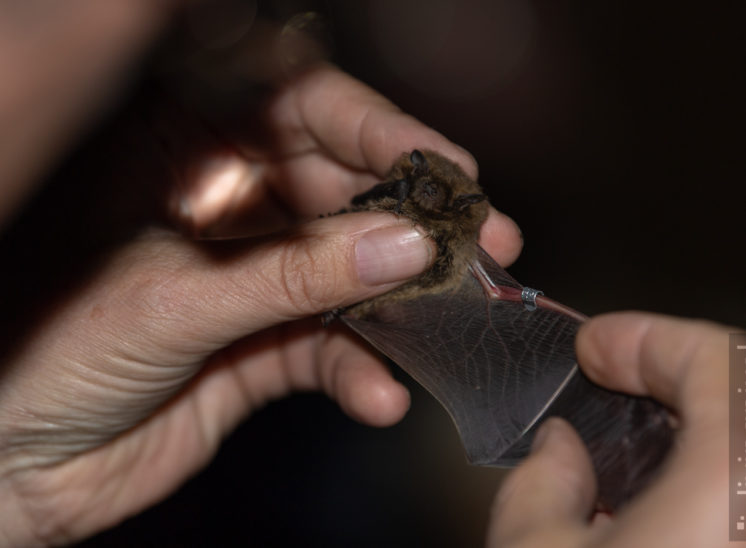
186, 0, 257, 49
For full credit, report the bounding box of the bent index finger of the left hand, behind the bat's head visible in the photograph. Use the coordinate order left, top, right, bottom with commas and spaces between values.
269, 63, 477, 178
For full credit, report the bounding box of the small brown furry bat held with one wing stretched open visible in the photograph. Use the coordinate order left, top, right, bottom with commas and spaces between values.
327, 150, 674, 511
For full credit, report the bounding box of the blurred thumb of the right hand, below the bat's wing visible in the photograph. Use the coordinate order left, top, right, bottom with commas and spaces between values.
488, 418, 596, 547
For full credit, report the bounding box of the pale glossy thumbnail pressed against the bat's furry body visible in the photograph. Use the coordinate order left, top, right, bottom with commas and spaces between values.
355, 226, 433, 285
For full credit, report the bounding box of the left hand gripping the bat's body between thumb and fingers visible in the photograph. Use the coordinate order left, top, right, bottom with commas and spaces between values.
0, 60, 520, 545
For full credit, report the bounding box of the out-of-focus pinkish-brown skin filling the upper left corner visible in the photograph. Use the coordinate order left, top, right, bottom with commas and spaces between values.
0, 0, 174, 227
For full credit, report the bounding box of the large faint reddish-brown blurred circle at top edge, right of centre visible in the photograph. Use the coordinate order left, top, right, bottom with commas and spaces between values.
370, 0, 535, 100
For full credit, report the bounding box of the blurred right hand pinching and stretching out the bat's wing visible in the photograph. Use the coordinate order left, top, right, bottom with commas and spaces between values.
487, 313, 731, 547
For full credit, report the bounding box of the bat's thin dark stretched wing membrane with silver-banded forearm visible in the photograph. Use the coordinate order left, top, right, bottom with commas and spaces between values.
342, 248, 673, 508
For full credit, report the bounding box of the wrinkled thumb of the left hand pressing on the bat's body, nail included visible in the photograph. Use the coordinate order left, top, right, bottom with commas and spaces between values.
113, 213, 435, 345
